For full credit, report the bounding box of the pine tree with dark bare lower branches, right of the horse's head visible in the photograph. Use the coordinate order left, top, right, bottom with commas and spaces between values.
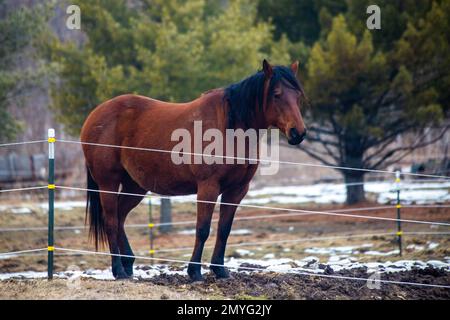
301, 1, 450, 203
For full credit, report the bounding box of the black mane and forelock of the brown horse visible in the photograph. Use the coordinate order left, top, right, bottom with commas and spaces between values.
223, 66, 303, 128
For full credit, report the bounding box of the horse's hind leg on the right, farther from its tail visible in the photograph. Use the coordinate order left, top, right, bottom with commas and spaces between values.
118, 174, 146, 277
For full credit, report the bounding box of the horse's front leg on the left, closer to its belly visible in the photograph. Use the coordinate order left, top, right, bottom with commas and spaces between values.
188, 183, 220, 281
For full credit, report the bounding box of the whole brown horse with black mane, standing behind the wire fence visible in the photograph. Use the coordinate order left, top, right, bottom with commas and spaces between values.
81, 60, 306, 280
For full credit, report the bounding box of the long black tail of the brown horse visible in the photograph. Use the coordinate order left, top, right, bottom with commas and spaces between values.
85, 168, 107, 250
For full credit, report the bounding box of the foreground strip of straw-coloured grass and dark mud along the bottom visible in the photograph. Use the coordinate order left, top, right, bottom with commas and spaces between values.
0, 268, 450, 300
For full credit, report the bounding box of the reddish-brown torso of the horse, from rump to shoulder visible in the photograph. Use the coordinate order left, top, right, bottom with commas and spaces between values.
81, 90, 246, 195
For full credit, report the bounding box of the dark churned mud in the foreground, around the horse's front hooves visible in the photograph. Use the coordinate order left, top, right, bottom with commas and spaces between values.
151, 268, 450, 300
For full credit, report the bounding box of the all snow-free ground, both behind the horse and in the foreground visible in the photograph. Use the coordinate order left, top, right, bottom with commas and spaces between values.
0, 202, 450, 299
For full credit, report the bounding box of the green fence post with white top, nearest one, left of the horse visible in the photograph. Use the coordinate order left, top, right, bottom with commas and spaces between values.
47, 129, 56, 280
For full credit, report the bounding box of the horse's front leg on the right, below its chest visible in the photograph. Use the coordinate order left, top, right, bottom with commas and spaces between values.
211, 184, 249, 278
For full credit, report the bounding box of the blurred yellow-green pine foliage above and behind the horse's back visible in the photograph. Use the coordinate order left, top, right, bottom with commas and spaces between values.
44, 0, 290, 135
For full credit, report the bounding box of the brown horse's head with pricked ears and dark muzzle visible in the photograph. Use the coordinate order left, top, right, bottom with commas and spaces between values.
263, 60, 306, 145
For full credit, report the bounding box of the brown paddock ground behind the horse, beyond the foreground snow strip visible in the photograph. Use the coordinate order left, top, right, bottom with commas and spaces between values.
0, 203, 450, 273
